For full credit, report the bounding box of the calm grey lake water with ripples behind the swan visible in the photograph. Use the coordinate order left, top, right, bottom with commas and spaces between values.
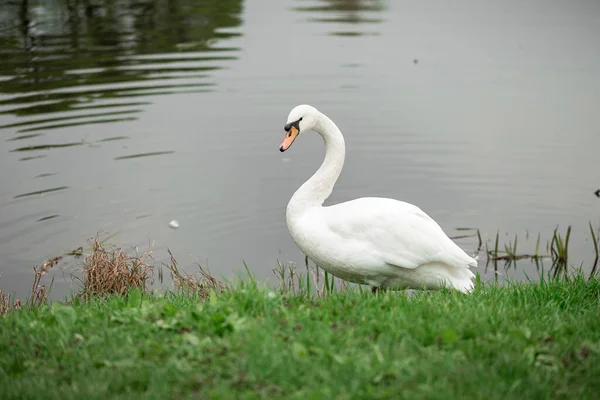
0, 0, 600, 296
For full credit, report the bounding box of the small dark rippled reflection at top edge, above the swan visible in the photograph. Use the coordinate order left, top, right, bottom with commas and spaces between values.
294, 0, 385, 36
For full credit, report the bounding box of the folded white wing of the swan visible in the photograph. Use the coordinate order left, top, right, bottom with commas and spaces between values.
325, 197, 477, 269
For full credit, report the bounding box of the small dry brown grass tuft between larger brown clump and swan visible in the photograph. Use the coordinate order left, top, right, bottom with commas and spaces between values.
165, 250, 229, 299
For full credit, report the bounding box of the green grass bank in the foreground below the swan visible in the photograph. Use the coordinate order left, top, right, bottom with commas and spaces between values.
0, 277, 600, 400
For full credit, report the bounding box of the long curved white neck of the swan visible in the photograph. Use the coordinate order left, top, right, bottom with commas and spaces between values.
287, 114, 346, 216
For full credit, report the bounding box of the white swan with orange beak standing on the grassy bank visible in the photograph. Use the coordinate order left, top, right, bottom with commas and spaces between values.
279, 105, 477, 293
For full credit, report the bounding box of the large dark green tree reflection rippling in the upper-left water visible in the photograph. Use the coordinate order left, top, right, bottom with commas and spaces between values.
0, 0, 242, 173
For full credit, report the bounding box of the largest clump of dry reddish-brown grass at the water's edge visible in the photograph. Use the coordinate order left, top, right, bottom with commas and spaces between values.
78, 236, 152, 298
